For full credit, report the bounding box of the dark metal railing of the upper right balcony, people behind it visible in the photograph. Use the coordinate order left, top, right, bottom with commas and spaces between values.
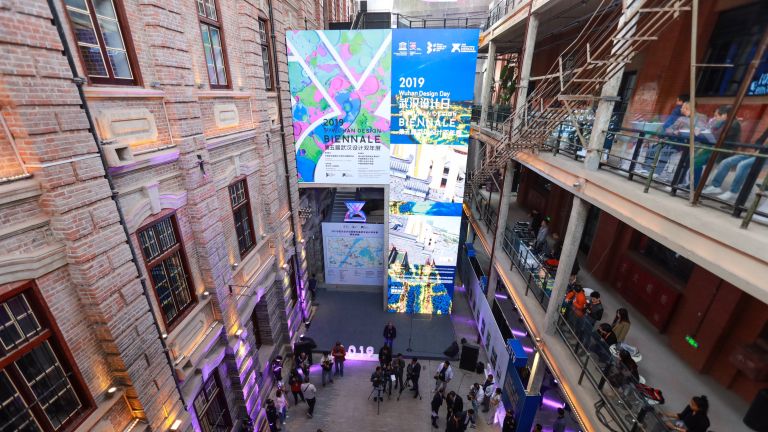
545, 116, 768, 228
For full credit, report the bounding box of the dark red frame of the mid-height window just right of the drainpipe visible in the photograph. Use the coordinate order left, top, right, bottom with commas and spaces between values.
136, 210, 198, 333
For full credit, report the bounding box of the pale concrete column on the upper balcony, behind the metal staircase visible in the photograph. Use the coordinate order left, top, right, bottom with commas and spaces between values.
584, 0, 642, 171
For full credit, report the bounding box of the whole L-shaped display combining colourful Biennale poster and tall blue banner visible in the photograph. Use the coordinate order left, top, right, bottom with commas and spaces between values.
287, 29, 479, 314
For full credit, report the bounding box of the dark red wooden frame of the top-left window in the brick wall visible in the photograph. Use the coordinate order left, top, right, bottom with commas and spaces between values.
63, 0, 143, 87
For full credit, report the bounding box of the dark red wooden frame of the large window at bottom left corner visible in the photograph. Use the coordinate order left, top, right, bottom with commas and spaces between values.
0, 281, 96, 432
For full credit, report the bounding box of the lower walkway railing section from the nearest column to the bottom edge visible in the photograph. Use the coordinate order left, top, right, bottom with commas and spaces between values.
557, 314, 669, 432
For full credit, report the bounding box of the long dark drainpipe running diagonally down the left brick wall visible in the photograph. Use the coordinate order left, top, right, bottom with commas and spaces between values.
48, 0, 187, 411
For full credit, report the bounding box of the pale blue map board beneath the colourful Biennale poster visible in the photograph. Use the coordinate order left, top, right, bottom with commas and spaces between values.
322, 222, 386, 285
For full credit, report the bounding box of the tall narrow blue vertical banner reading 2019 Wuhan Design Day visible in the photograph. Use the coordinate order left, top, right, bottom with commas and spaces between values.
387, 29, 479, 314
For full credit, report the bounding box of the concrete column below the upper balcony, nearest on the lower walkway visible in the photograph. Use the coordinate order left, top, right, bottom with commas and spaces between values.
545, 196, 589, 334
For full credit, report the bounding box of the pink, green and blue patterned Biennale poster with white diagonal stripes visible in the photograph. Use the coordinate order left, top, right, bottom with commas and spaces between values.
286, 30, 392, 185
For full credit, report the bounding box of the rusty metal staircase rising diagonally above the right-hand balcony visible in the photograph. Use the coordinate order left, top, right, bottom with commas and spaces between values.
466, 0, 690, 198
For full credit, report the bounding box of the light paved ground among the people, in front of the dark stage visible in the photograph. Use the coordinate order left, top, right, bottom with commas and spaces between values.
268, 360, 508, 432
